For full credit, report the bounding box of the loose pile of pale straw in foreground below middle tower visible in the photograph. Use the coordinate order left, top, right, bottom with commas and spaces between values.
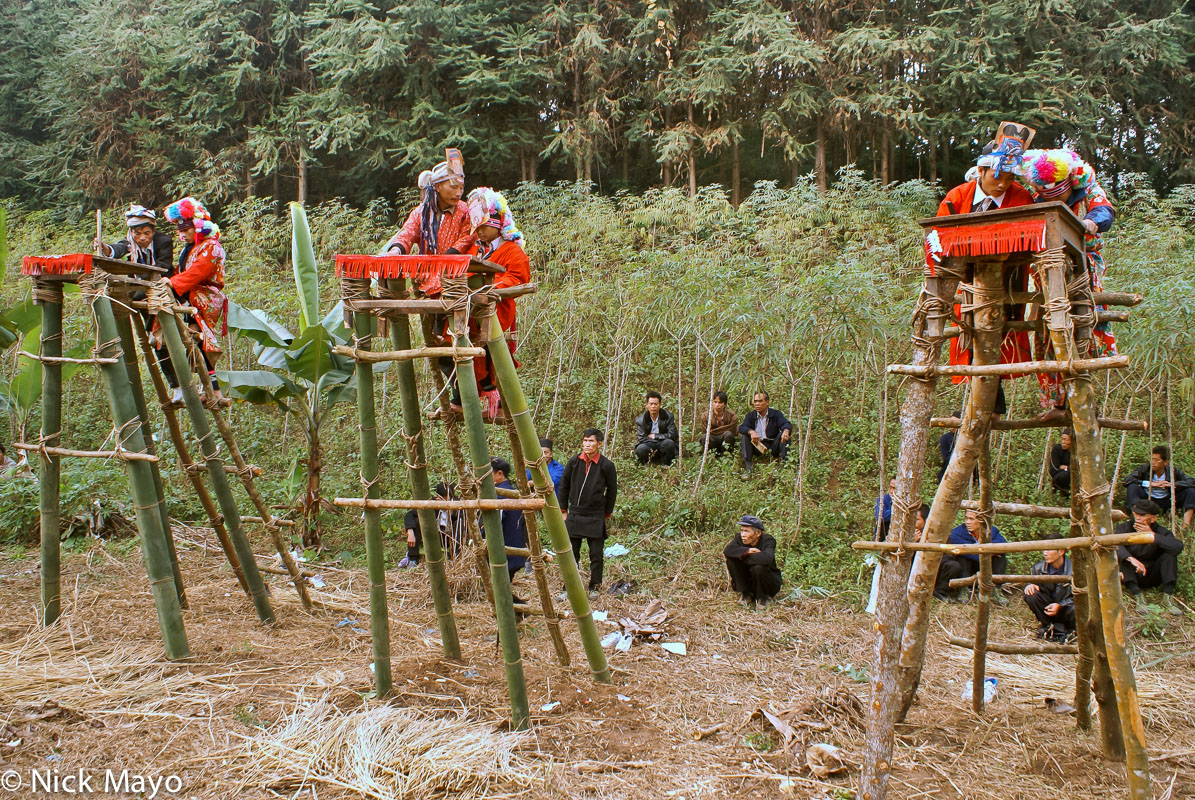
241, 694, 545, 800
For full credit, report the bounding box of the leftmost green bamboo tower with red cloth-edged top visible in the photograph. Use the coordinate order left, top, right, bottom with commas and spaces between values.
16, 254, 312, 660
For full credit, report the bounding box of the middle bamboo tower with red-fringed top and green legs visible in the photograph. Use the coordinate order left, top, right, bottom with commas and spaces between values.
335, 255, 611, 729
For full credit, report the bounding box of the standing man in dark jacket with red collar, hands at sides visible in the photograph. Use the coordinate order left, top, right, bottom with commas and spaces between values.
558, 428, 618, 597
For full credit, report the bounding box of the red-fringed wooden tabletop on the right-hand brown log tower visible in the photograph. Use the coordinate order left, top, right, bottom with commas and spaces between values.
918, 202, 1083, 275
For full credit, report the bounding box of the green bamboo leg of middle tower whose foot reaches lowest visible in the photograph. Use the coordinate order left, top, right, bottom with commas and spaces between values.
453, 313, 531, 731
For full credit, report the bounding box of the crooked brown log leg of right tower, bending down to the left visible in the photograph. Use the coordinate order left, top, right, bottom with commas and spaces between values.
897, 262, 1004, 719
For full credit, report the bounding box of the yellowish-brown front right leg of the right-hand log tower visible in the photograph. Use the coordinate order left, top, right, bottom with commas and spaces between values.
1042, 251, 1153, 779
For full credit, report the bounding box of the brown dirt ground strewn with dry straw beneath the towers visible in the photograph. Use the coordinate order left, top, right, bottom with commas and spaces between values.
0, 530, 1195, 800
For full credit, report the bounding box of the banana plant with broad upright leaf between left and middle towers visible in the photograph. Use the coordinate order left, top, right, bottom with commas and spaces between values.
216, 203, 372, 548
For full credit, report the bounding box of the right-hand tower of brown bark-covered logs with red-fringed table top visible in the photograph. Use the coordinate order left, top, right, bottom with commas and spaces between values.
853, 202, 1153, 800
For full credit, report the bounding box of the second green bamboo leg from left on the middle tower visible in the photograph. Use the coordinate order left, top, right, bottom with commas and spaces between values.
386, 281, 460, 661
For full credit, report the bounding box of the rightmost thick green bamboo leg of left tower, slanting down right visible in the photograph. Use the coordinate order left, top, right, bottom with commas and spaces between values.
158, 311, 275, 624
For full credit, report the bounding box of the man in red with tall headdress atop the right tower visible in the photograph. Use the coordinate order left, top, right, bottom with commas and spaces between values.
937, 122, 1035, 389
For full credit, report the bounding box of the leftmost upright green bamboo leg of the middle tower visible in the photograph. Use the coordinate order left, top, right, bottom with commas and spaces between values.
342, 280, 394, 697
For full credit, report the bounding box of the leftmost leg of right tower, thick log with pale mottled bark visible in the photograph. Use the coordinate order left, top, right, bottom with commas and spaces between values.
860, 275, 958, 800
